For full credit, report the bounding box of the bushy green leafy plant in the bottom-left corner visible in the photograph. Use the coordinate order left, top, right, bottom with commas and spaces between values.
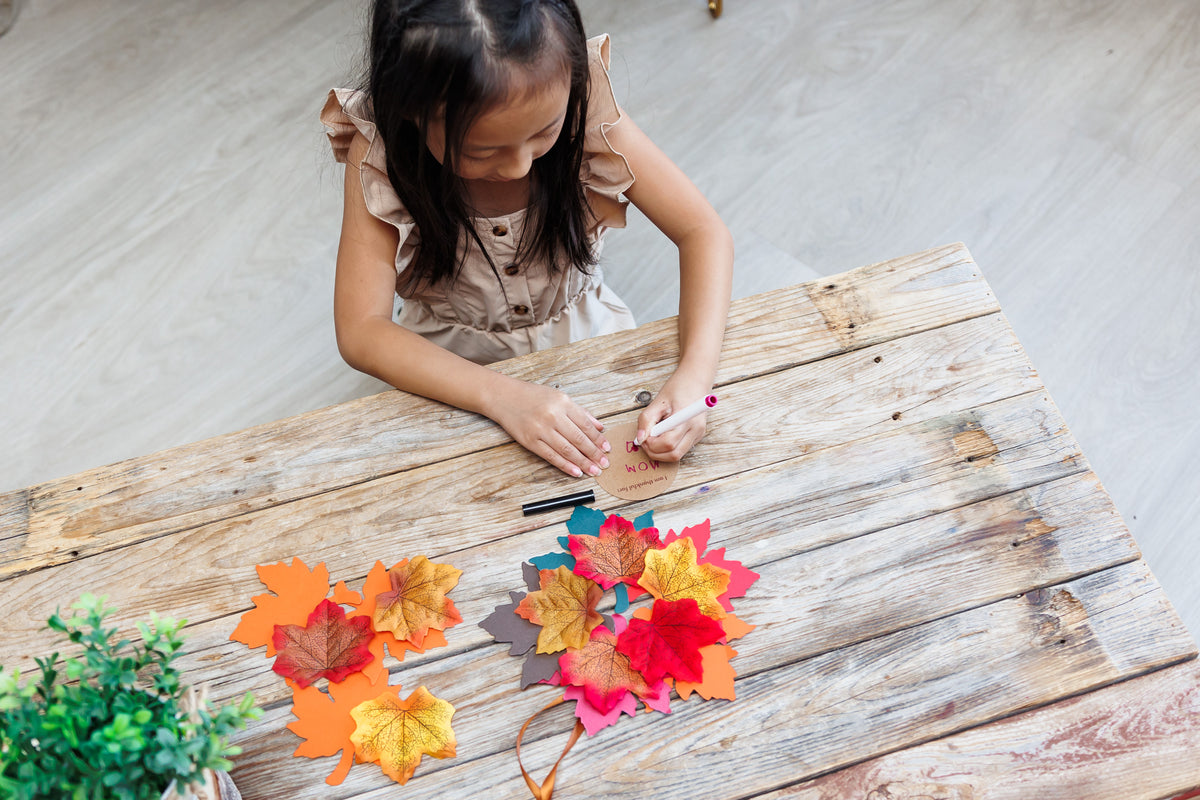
0, 594, 259, 800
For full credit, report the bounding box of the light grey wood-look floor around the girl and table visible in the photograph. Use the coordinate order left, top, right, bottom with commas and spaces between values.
0, 0, 1200, 634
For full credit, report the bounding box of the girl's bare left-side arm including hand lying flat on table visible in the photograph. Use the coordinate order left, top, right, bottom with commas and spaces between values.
334, 136, 608, 477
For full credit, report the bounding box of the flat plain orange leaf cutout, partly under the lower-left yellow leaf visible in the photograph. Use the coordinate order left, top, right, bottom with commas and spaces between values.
288, 672, 400, 786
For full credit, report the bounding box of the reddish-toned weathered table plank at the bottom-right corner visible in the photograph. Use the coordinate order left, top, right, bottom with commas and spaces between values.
760, 661, 1200, 800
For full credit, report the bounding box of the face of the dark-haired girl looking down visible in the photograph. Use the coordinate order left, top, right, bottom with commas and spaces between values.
426, 78, 570, 181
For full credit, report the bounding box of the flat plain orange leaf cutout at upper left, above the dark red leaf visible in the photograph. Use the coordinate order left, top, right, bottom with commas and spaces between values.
229, 558, 329, 657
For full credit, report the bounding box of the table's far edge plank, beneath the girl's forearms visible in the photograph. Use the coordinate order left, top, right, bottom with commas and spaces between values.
0, 245, 998, 571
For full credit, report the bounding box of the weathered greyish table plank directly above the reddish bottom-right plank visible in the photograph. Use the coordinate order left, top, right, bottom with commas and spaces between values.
226, 563, 1195, 800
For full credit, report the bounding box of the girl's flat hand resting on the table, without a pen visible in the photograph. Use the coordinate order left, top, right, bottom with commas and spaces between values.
487, 380, 611, 477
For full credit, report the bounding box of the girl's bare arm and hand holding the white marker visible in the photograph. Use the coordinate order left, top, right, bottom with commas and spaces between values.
607, 114, 733, 461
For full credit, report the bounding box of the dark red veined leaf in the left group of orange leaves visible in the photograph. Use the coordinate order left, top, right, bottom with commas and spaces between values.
271, 600, 374, 688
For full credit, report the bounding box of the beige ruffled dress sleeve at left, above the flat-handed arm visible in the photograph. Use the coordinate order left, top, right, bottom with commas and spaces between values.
320, 89, 420, 273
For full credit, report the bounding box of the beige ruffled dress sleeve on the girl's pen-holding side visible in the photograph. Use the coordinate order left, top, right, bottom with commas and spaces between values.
580, 34, 634, 236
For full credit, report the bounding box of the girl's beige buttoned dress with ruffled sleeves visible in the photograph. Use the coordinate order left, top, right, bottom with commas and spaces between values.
320, 35, 635, 363
